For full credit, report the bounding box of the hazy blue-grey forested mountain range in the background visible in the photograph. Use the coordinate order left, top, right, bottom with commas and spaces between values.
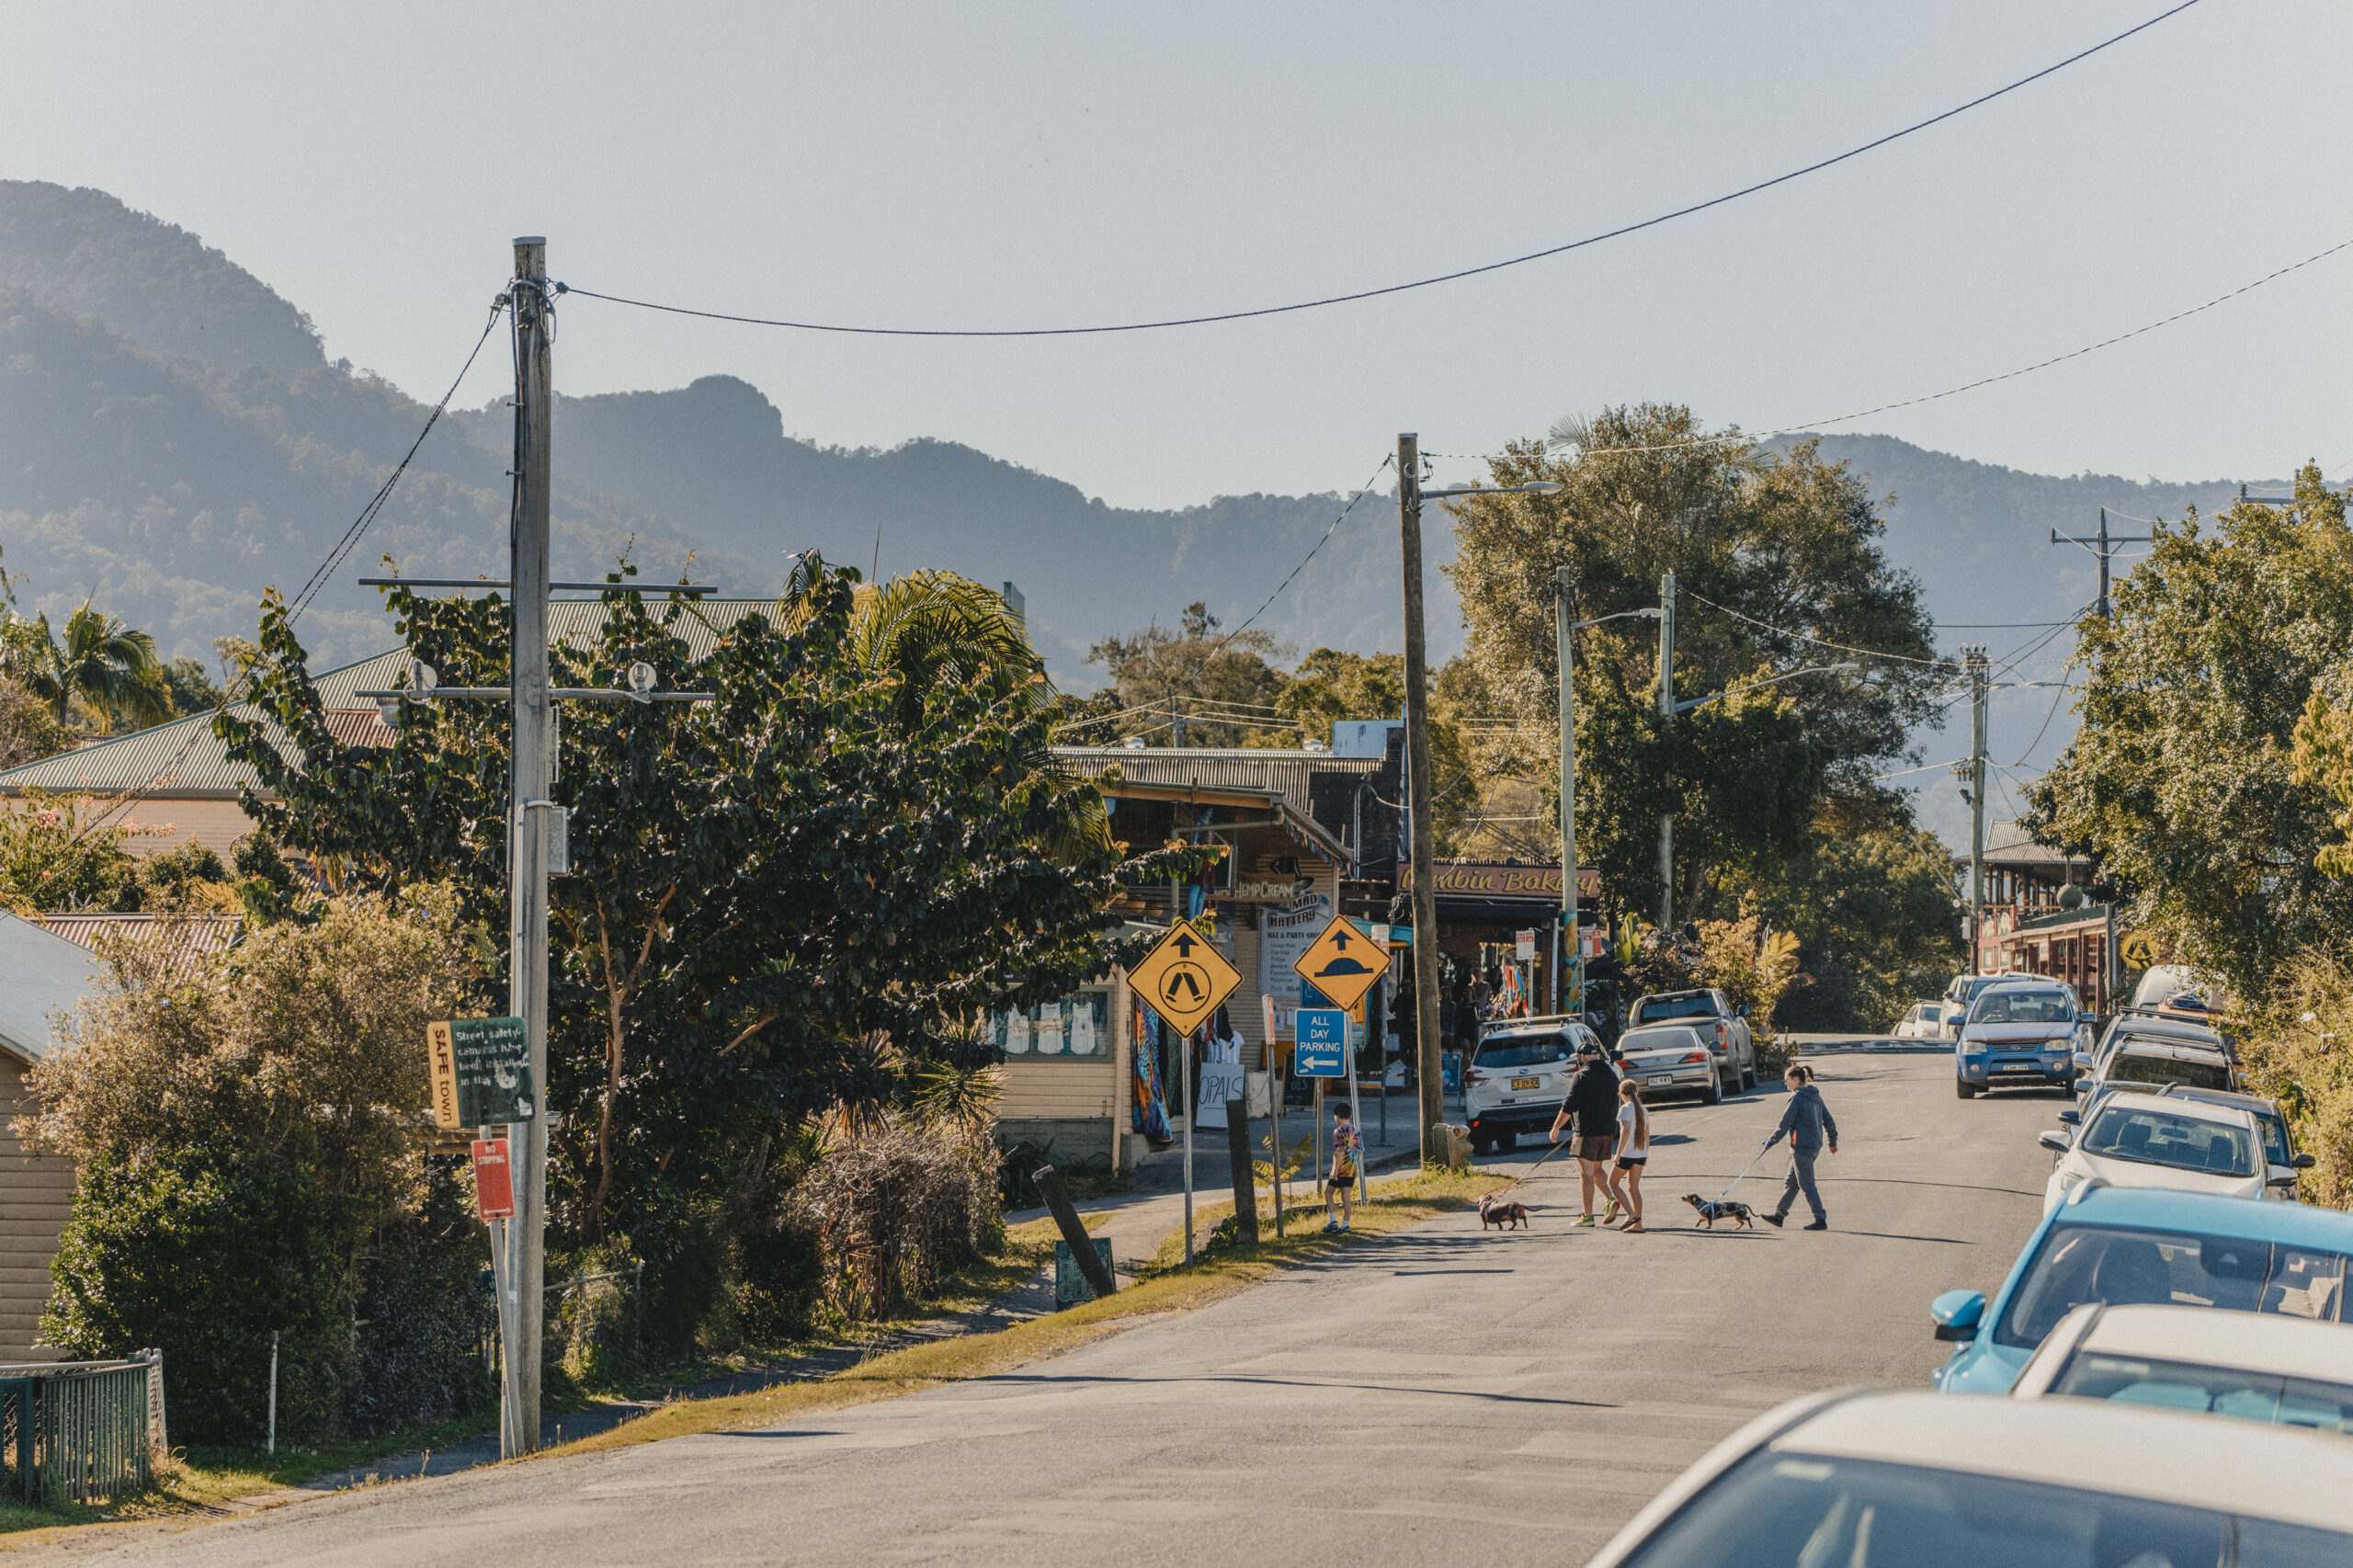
0, 181, 2278, 857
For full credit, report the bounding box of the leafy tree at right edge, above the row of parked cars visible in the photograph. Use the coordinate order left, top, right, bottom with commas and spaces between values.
2029, 466, 2353, 998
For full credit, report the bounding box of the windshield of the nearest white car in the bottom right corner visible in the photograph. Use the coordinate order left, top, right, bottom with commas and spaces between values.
1626, 1448, 2353, 1568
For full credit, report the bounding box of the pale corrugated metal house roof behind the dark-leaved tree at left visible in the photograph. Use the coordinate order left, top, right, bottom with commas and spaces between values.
0, 598, 777, 801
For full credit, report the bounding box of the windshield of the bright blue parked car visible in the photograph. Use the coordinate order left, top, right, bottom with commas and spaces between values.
1993, 1206, 2346, 1349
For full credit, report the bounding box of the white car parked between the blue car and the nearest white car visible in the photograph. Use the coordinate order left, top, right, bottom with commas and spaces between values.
2009, 1302, 2353, 1437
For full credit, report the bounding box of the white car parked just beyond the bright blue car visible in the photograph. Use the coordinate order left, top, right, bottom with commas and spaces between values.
2042, 1090, 2270, 1215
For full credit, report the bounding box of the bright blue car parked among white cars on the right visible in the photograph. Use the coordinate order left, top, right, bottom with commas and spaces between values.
1927, 1182, 2353, 1393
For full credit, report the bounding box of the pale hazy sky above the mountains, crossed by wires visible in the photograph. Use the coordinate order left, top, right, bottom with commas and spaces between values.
0, 0, 2353, 506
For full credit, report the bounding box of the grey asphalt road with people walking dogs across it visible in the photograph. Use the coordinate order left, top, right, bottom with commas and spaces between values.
38, 1052, 2063, 1568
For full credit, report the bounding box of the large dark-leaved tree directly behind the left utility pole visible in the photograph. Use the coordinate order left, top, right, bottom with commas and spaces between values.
214, 572, 1188, 1244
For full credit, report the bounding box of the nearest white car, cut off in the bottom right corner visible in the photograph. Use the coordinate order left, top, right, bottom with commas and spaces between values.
1586, 1389, 2353, 1568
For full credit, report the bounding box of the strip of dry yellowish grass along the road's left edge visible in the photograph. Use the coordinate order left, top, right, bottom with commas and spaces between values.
560, 1173, 1506, 1452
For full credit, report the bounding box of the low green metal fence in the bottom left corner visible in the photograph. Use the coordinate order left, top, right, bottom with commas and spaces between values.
0, 1351, 165, 1502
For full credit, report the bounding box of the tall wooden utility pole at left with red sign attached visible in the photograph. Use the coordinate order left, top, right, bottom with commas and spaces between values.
499, 235, 555, 1458
